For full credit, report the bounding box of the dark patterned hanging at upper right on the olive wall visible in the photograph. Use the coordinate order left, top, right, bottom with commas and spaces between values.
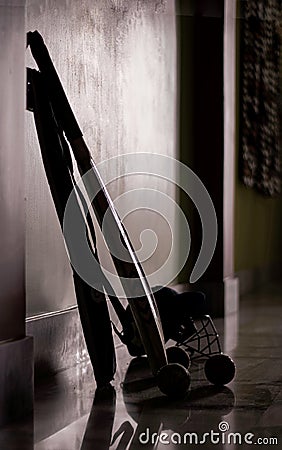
240, 0, 281, 196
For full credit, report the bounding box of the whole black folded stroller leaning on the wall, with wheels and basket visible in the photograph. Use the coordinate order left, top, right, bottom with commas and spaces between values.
27, 31, 235, 397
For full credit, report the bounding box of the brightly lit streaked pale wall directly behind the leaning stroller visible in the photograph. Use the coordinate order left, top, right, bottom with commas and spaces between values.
26, 0, 176, 316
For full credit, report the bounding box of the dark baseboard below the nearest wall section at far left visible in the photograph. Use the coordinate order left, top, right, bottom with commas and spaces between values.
0, 336, 33, 426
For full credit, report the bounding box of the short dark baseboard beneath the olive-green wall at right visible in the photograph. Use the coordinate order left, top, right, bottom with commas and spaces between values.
236, 263, 282, 295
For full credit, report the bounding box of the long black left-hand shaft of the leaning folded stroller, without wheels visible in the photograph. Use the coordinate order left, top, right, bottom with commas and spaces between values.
27, 69, 116, 385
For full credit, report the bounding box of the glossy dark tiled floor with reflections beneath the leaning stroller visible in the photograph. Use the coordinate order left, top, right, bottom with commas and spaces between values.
0, 285, 282, 450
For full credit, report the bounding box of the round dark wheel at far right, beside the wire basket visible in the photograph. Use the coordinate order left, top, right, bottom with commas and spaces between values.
205, 353, 235, 386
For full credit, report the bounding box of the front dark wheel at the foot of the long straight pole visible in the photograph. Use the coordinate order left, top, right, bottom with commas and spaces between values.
156, 363, 190, 398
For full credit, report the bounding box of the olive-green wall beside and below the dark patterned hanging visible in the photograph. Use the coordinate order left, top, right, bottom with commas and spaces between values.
234, 8, 282, 272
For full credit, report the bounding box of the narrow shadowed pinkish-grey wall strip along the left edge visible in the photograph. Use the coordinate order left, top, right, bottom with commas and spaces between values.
0, 0, 25, 340
